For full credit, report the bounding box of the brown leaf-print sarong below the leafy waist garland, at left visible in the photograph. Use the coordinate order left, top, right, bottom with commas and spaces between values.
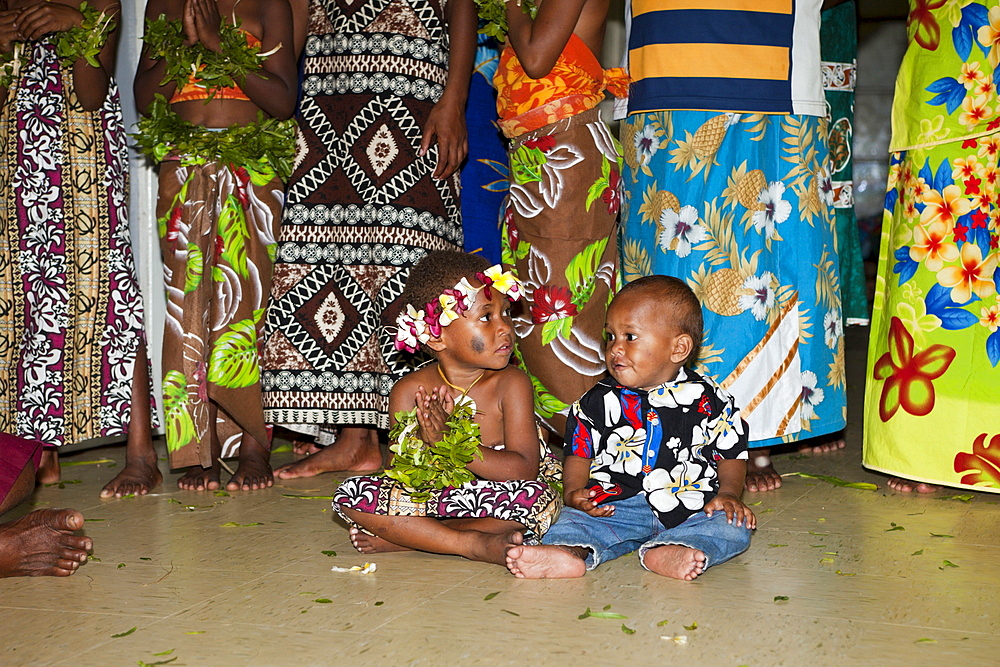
156, 161, 284, 468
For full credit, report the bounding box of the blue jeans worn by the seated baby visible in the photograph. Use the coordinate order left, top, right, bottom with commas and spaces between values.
542, 495, 751, 570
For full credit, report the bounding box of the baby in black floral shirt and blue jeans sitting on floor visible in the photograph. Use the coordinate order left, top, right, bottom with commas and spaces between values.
507, 276, 757, 581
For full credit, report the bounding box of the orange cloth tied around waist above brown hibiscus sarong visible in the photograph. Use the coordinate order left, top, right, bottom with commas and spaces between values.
493, 33, 629, 137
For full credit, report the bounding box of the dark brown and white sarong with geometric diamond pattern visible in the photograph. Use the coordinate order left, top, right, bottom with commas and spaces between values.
263, 0, 462, 435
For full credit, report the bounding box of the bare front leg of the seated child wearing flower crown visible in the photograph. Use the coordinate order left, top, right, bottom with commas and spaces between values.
343, 507, 523, 565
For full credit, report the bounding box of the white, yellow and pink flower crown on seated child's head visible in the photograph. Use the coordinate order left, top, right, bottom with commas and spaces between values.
396, 264, 523, 352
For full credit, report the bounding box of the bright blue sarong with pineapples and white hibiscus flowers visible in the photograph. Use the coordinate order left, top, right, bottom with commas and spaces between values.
621, 111, 846, 447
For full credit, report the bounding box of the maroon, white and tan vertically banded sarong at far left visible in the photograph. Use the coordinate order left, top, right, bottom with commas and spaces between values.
0, 40, 156, 445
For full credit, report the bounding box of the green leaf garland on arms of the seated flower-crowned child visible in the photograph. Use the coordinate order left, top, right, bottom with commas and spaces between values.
385, 399, 483, 502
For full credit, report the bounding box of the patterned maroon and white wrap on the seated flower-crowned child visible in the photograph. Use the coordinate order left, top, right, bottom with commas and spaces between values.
333, 433, 562, 544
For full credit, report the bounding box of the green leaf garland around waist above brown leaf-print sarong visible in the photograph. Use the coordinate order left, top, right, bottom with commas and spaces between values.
132, 95, 295, 185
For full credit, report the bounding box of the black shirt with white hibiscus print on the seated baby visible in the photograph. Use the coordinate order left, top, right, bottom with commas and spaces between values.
564, 368, 747, 528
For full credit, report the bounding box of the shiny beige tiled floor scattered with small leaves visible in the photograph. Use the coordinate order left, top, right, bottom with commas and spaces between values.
0, 329, 1000, 667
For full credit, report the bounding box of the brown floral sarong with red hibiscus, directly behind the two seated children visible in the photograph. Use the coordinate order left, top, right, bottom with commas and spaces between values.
503, 109, 621, 434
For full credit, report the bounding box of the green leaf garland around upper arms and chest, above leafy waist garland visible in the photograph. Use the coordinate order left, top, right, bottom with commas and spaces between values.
142, 14, 266, 100
